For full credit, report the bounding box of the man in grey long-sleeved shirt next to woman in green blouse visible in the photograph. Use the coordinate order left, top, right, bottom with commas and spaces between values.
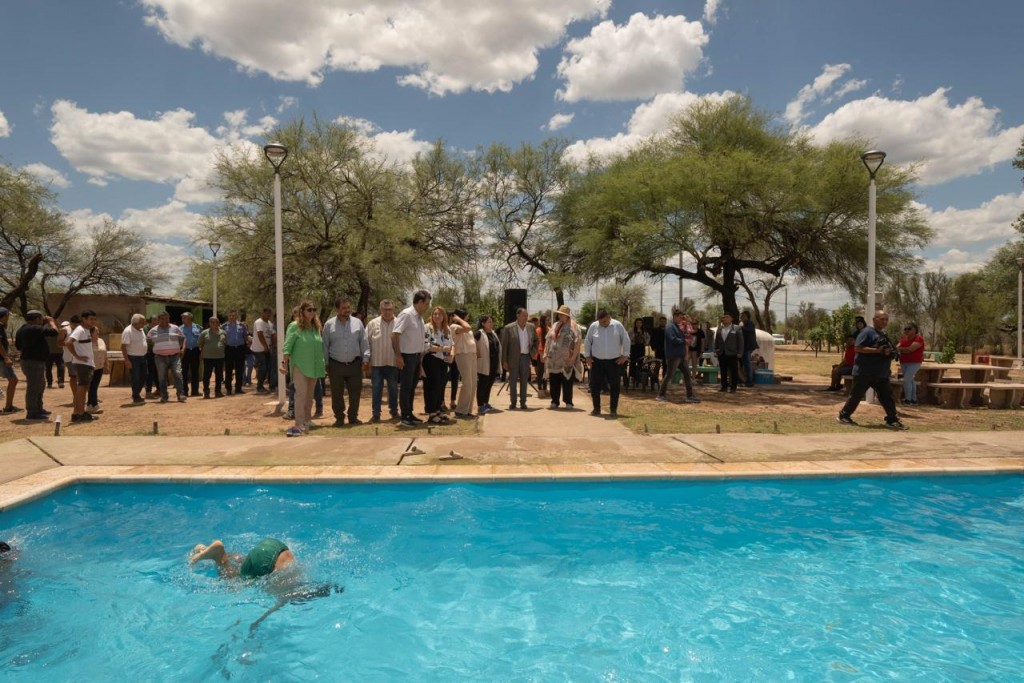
323, 297, 370, 427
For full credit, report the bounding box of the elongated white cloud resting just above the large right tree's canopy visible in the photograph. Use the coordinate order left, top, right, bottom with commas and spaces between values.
565, 91, 735, 163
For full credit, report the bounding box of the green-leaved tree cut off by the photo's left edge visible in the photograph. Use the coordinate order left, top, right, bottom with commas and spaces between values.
0, 164, 72, 314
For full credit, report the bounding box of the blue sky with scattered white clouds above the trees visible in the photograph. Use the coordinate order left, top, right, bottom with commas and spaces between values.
0, 0, 1024, 311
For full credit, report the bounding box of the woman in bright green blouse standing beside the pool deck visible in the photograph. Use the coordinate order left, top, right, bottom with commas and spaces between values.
281, 301, 327, 436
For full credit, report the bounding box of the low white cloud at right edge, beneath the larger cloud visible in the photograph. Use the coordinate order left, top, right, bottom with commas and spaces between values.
916, 193, 1024, 250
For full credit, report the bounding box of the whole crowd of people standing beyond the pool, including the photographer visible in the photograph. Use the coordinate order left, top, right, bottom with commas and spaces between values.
0, 290, 925, 436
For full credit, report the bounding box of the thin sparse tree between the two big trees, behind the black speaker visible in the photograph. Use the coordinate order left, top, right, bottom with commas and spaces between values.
480, 138, 584, 306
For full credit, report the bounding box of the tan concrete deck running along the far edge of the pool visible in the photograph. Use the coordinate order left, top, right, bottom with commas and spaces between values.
0, 423, 1024, 510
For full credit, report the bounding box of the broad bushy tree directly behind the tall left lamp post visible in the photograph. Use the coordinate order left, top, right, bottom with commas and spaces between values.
185, 117, 474, 312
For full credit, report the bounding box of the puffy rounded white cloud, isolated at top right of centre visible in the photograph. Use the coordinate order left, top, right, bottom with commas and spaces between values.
558, 13, 708, 102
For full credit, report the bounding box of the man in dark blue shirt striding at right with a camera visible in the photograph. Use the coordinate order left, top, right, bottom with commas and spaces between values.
838, 310, 906, 431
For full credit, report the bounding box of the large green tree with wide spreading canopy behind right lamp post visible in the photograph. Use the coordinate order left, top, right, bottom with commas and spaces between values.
564, 96, 932, 311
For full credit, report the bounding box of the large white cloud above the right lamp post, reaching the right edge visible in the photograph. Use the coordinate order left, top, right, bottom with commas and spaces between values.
809, 88, 1024, 184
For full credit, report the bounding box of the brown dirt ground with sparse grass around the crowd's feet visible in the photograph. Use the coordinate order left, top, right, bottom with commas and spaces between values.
0, 349, 1024, 440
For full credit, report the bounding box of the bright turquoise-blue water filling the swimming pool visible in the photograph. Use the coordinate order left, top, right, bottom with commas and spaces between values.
0, 477, 1024, 683
